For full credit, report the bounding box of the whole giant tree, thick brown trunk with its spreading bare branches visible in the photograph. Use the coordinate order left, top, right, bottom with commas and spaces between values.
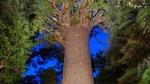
44, 0, 106, 84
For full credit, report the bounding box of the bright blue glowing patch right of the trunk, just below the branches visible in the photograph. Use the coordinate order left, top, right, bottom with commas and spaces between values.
89, 26, 109, 56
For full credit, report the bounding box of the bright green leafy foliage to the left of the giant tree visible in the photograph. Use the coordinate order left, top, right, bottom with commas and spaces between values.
0, 0, 42, 84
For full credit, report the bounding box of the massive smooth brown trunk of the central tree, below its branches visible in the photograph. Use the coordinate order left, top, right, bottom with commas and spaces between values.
62, 24, 94, 84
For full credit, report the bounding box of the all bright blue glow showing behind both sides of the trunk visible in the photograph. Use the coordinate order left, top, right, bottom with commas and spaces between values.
22, 26, 109, 84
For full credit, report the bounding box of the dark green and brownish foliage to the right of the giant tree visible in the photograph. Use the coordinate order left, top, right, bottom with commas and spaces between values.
102, 0, 150, 84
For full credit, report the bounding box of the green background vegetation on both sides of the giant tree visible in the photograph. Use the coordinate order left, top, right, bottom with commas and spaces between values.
0, 0, 150, 84
